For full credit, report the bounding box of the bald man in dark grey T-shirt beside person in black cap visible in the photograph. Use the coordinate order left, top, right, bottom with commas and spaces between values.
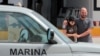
74, 7, 92, 42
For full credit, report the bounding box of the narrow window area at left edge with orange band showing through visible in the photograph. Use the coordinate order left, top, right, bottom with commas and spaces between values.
0, 13, 8, 41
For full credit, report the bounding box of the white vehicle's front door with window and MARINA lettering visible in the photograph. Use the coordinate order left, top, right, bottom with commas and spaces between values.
0, 12, 72, 56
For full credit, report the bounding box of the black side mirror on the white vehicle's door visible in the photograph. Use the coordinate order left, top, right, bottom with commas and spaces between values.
47, 29, 57, 44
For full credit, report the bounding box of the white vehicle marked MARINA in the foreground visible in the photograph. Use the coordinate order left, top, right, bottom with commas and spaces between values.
0, 5, 100, 56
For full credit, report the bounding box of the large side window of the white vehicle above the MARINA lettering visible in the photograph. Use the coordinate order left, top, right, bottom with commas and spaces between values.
0, 12, 47, 43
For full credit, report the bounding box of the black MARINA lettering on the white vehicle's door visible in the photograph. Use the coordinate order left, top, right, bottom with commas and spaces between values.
10, 48, 47, 55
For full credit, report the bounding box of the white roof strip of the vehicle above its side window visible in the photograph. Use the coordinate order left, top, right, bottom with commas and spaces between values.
0, 5, 32, 12
